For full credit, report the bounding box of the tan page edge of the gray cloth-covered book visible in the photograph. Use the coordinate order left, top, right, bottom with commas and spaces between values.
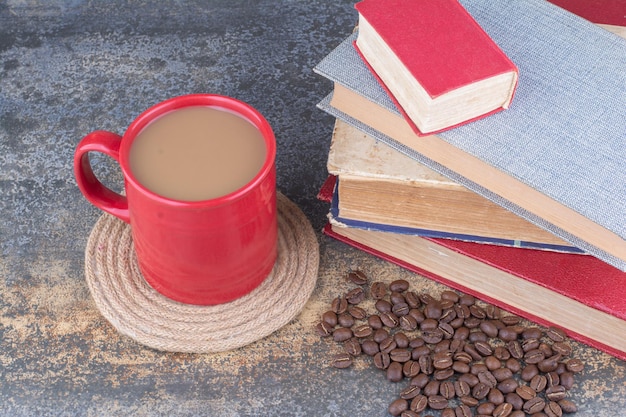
330, 83, 626, 261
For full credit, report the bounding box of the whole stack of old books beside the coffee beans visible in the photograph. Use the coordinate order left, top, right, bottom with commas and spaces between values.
315, 0, 626, 359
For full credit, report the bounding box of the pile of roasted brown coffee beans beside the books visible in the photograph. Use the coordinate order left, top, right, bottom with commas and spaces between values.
316, 270, 584, 417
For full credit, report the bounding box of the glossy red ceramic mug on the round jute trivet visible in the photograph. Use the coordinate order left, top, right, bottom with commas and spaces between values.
74, 94, 277, 305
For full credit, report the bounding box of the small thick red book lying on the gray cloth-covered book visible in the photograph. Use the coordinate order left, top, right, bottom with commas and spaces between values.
355, 0, 517, 135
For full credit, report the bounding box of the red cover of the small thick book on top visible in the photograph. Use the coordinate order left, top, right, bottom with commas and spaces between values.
355, 0, 517, 135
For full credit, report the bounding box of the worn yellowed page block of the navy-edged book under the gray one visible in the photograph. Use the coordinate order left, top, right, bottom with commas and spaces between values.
327, 120, 569, 246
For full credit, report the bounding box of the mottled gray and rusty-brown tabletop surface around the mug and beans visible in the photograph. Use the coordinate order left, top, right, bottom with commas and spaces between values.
0, 0, 626, 417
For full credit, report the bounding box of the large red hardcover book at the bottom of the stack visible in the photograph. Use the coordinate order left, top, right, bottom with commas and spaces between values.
318, 182, 626, 360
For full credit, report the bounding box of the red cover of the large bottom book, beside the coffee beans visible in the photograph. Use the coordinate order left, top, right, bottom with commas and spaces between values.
323, 224, 626, 360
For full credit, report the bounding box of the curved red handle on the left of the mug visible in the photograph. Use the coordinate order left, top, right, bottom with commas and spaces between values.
74, 130, 130, 223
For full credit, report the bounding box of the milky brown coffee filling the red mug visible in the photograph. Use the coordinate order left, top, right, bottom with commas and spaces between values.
130, 106, 266, 201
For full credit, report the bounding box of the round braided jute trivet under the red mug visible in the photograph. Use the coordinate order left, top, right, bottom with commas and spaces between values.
85, 192, 319, 353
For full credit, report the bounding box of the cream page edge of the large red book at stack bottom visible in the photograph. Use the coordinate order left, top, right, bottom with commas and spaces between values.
333, 226, 626, 351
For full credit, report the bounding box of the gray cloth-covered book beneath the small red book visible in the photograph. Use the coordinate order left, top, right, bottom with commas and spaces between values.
315, 0, 626, 270
